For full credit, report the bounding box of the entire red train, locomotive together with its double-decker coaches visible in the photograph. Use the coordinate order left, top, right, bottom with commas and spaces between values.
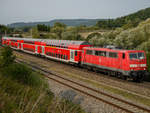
2, 37, 147, 81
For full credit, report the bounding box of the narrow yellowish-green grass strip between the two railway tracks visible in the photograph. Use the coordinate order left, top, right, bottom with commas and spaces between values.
51, 68, 150, 106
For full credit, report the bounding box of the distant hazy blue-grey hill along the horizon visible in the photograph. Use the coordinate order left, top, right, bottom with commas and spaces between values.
8, 19, 103, 28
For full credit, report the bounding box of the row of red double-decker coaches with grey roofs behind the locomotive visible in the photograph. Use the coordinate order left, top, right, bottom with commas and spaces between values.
2, 37, 91, 64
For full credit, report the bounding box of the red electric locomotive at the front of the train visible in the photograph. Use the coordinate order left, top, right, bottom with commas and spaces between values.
81, 47, 147, 81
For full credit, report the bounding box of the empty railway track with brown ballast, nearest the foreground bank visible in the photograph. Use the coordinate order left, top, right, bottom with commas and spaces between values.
17, 59, 150, 113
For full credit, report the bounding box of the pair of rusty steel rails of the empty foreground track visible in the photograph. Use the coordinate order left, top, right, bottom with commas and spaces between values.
17, 60, 150, 113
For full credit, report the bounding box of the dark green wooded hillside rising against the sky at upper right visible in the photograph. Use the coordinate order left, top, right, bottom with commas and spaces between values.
96, 8, 150, 29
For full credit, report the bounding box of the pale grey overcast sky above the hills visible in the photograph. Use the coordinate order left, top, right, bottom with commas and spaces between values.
0, 0, 150, 25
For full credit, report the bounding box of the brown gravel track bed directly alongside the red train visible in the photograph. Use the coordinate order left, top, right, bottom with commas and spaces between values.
15, 51, 150, 99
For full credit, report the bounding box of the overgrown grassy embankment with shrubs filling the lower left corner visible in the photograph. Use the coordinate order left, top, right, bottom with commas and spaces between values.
0, 48, 84, 113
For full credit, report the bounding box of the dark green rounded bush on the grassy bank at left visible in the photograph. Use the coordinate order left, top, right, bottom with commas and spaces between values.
3, 63, 42, 86
